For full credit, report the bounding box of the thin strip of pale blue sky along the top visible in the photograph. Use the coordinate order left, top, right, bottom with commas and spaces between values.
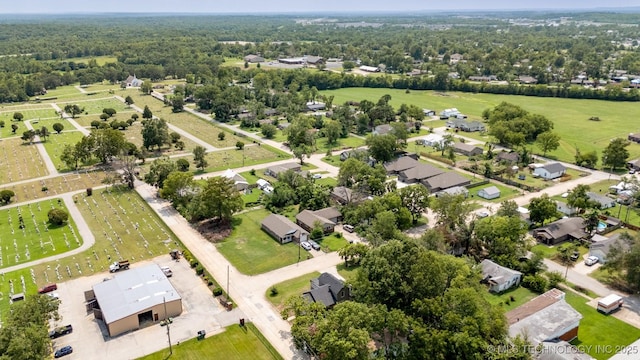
0, 0, 640, 14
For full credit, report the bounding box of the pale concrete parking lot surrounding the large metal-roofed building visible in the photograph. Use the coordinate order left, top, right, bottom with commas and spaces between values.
52, 255, 244, 360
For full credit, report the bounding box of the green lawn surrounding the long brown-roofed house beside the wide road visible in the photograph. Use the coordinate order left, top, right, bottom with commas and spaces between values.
216, 209, 305, 275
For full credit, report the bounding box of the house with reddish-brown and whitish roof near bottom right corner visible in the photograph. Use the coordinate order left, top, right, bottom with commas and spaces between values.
506, 289, 582, 346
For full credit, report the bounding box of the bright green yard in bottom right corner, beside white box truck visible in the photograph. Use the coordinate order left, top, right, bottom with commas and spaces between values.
565, 291, 640, 360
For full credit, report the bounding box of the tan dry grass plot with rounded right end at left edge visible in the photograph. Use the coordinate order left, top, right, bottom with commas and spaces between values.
0, 138, 47, 184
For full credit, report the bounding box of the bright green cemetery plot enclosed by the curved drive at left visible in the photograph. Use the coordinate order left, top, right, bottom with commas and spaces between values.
0, 199, 82, 270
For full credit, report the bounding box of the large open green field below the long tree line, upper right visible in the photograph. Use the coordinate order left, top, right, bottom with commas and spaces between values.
322, 88, 640, 162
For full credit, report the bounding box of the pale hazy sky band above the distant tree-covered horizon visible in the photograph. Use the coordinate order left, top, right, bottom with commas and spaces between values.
0, 0, 640, 15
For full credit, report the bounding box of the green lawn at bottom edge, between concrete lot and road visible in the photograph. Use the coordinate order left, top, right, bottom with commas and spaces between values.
140, 323, 282, 360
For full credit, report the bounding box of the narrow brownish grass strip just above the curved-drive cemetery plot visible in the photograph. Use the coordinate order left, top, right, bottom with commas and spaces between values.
0, 172, 104, 203
